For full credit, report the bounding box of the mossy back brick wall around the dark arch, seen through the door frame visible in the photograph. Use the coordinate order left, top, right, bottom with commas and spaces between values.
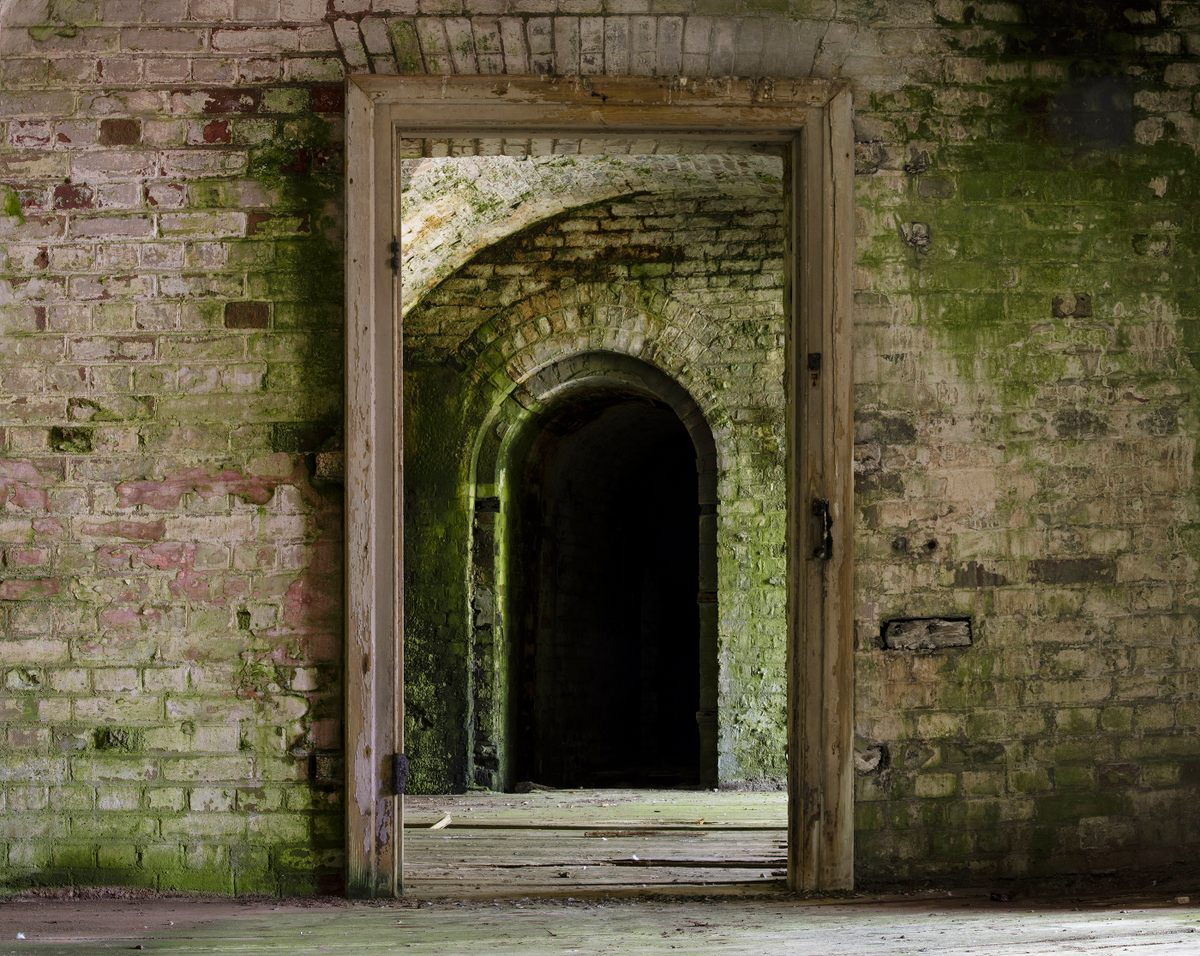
404, 164, 786, 792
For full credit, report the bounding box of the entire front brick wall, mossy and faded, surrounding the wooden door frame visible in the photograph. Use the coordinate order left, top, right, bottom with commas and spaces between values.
0, 0, 1200, 891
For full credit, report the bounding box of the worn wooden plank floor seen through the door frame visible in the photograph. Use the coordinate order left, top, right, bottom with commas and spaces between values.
404, 790, 787, 898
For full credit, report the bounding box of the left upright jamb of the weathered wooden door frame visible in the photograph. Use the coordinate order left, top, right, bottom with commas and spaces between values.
344, 78, 403, 897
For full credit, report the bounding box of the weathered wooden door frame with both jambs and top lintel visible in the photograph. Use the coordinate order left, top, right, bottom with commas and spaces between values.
344, 76, 854, 897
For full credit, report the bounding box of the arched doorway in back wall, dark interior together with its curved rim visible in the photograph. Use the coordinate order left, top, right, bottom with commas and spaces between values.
465, 353, 716, 787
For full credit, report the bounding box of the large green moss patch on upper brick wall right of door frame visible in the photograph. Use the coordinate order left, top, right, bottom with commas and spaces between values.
859, 73, 1200, 429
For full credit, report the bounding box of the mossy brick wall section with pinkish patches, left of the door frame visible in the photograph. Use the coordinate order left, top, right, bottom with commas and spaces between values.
0, 4, 343, 892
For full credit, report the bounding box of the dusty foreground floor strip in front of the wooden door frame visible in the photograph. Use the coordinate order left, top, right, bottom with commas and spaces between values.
0, 895, 1200, 956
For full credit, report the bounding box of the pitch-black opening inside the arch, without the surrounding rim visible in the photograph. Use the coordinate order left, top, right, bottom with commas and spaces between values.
510, 391, 702, 787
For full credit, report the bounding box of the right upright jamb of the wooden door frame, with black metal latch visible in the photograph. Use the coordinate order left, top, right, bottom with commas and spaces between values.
788, 85, 854, 891
